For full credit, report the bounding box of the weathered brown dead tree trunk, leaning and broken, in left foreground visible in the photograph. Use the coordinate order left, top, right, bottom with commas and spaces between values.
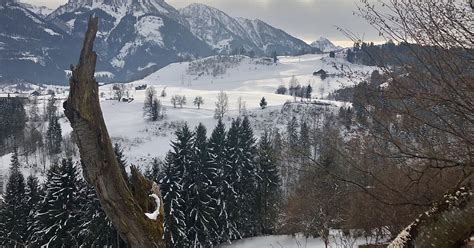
64, 17, 165, 248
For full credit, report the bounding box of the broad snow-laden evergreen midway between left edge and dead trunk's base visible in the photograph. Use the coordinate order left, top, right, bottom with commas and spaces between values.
30, 159, 79, 247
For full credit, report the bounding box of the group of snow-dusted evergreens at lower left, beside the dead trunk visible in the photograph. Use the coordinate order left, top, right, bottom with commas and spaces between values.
0, 146, 130, 247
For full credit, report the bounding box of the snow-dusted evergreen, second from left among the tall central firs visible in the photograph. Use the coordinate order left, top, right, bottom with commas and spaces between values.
186, 123, 217, 247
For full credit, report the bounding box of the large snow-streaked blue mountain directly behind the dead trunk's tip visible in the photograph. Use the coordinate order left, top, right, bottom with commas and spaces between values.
48, 0, 211, 80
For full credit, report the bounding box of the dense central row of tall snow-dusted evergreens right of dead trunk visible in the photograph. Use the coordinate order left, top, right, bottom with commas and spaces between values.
149, 118, 280, 247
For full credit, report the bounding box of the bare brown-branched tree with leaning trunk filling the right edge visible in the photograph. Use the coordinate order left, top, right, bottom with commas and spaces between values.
334, 0, 474, 247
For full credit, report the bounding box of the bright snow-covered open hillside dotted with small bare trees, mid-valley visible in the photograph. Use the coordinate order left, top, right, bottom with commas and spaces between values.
101, 55, 371, 164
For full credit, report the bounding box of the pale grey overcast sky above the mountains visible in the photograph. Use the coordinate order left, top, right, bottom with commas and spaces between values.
20, 0, 386, 46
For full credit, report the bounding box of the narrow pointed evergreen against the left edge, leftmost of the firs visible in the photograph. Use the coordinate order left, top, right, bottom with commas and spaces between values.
0, 149, 28, 247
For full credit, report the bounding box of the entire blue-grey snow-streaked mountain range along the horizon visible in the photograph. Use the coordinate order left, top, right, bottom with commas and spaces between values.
0, 0, 317, 84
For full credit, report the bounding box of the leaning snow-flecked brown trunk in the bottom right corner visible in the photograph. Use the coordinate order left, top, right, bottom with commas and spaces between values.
389, 176, 474, 248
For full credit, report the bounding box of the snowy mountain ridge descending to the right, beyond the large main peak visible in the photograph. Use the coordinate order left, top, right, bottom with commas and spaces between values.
180, 4, 311, 54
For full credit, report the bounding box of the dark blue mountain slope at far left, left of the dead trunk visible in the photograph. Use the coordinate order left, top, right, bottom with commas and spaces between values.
0, 1, 80, 83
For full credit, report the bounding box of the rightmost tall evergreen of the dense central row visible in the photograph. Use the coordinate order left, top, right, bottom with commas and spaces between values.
256, 131, 281, 234
